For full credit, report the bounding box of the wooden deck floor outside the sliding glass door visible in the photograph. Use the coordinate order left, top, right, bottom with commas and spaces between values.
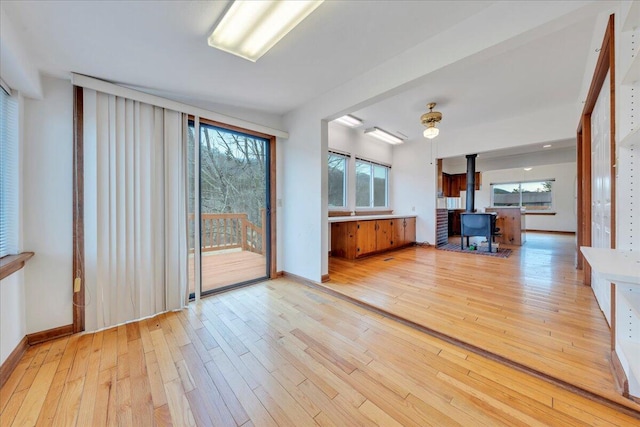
189, 249, 267, 292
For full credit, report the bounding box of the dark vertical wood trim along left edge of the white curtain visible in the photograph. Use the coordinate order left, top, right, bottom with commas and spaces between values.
71, 86, 85, 333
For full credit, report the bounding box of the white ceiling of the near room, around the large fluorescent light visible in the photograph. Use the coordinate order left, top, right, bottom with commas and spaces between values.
2, 0, 489, 114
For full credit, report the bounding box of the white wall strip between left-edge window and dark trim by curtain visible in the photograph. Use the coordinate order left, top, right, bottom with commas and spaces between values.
22, 77, 73, 333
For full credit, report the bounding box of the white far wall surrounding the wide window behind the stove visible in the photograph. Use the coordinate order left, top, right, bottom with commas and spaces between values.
476, 162, 577, 232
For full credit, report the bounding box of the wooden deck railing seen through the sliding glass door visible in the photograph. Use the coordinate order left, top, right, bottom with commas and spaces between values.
189, 209, 266, 254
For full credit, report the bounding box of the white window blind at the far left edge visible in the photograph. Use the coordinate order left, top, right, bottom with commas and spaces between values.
0, 85, 19, 258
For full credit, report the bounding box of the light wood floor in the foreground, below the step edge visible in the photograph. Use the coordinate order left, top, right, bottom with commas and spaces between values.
0, 278, 640, 427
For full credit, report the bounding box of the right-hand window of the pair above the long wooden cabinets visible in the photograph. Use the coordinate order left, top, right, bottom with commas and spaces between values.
356, 159, 390, 208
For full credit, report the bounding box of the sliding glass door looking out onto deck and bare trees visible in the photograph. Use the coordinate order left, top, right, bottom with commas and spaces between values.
189, 123, 271, 295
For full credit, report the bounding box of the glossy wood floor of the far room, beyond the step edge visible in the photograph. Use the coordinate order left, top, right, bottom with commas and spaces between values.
323, 233, 640, 410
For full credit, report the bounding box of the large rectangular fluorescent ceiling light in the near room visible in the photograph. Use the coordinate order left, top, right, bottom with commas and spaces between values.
208, 0, 323, 62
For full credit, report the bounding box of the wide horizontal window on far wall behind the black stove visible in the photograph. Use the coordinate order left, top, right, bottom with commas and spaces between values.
491, 179, 555, 211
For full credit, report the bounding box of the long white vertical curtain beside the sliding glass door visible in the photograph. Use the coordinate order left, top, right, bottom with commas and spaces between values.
83, 88, 188, 331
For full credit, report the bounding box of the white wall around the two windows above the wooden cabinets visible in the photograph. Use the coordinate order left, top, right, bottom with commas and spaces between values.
328, 122, 394, 211
